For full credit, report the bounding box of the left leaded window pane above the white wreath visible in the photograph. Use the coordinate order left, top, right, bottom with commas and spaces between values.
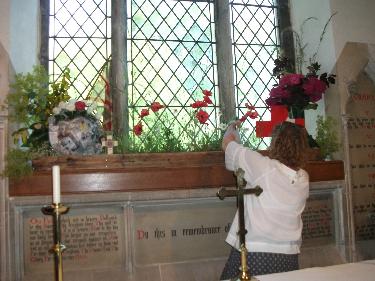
49, 0, 111, 107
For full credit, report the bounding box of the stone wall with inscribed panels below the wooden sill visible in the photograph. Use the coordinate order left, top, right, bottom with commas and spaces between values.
9, 181, 345, 281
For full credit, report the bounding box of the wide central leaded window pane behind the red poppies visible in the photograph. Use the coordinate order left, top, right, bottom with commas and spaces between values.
127, 0, 220, 151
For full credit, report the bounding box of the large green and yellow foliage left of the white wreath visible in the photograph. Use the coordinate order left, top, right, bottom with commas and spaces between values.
5, 65, 70, 148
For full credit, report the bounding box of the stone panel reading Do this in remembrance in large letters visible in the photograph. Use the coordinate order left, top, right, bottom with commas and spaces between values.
132, 198, 237, 265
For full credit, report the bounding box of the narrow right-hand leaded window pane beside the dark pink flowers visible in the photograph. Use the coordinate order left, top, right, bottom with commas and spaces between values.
230, 0, 279, 149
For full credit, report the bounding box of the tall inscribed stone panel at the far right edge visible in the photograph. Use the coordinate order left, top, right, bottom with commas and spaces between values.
346, 66, 375, 240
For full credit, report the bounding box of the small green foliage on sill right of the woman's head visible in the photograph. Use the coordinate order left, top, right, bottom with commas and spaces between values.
315, 116, 340, 159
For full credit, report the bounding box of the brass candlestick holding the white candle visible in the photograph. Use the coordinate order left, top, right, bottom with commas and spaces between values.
42, 203, 69, 281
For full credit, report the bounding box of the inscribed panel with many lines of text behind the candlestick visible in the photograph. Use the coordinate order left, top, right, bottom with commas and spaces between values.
22, 206, 125, 274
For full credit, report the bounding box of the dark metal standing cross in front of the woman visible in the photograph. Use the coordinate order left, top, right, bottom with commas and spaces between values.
217, 168, 263, 281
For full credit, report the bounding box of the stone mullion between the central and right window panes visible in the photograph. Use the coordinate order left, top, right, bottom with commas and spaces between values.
215, 0, 236, 122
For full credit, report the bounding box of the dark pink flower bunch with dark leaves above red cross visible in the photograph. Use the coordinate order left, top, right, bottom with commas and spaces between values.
266, 58, 335, 111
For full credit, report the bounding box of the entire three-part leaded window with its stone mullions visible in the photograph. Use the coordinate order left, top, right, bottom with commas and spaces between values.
40, 0, 292, 151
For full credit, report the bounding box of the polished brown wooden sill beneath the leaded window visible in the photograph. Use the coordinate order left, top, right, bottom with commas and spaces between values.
9, 152, 344, 196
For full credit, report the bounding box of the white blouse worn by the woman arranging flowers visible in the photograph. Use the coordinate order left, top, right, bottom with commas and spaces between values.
225, 141, 309, 254
